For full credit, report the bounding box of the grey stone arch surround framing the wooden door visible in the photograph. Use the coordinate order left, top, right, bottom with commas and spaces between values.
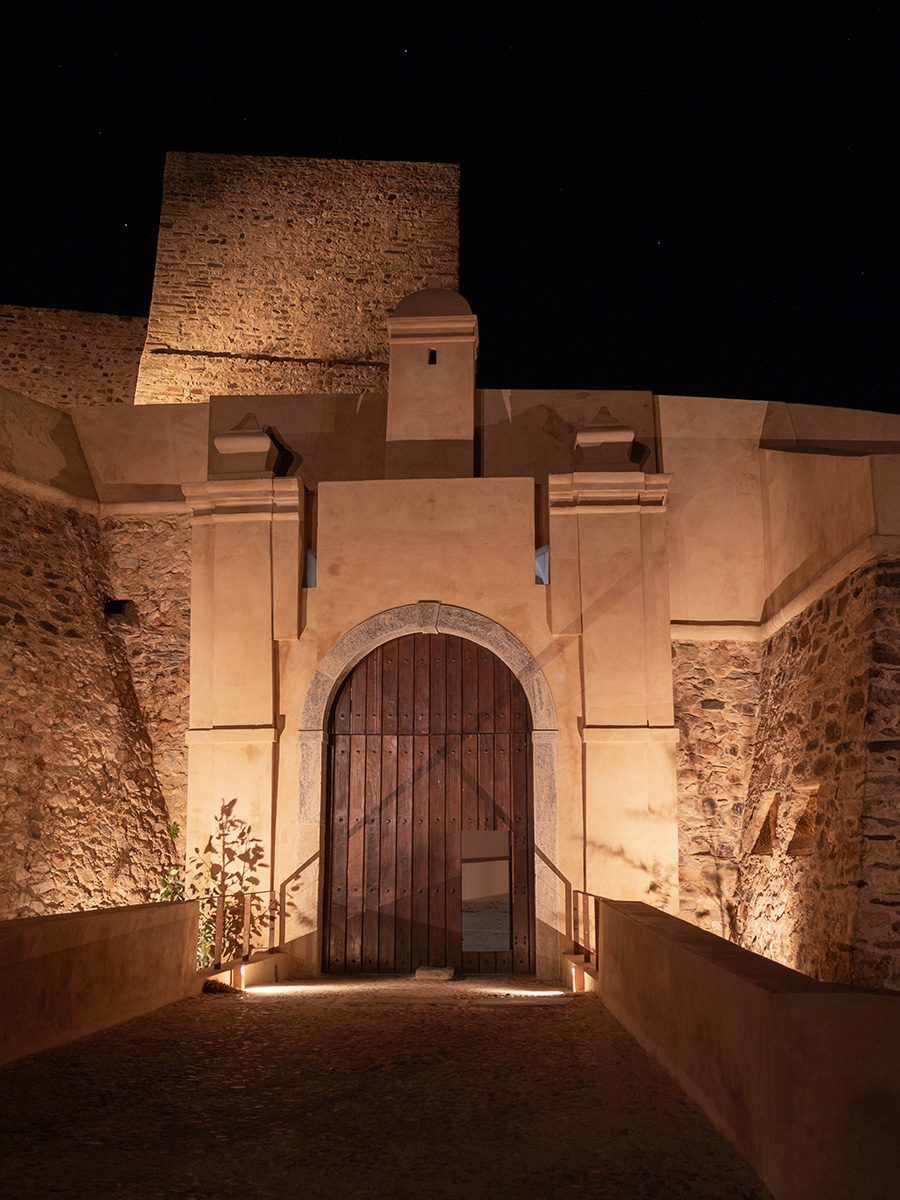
298, 600, 566, 978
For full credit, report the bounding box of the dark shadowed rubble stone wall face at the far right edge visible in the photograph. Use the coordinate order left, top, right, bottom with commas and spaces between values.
853, 562, 900, 989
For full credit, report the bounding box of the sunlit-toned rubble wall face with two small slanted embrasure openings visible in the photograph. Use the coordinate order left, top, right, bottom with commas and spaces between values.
738, 566, 875, 983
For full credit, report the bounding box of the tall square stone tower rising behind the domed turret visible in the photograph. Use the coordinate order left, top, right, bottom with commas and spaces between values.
137, 154, 458, 403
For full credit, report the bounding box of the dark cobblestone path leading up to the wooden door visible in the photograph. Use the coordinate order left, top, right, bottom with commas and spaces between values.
0, 979, 769, 1200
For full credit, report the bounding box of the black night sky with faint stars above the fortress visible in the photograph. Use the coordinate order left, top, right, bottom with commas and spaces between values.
0, 0, 900, 409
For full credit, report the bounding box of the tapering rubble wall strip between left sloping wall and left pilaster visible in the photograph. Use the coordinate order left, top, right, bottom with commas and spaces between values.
101, 515, 191, 850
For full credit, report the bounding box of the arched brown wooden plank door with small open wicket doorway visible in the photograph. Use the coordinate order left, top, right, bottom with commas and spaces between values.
323, 634, 534, 974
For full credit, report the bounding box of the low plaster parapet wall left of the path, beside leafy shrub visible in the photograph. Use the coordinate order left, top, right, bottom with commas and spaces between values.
0, 900, 199, 1063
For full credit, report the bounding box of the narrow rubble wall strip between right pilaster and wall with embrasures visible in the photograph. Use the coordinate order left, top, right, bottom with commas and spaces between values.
672, 641, 760, 937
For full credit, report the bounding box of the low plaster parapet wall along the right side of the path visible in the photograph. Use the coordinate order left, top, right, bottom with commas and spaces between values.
564, 900, 900, 1200
